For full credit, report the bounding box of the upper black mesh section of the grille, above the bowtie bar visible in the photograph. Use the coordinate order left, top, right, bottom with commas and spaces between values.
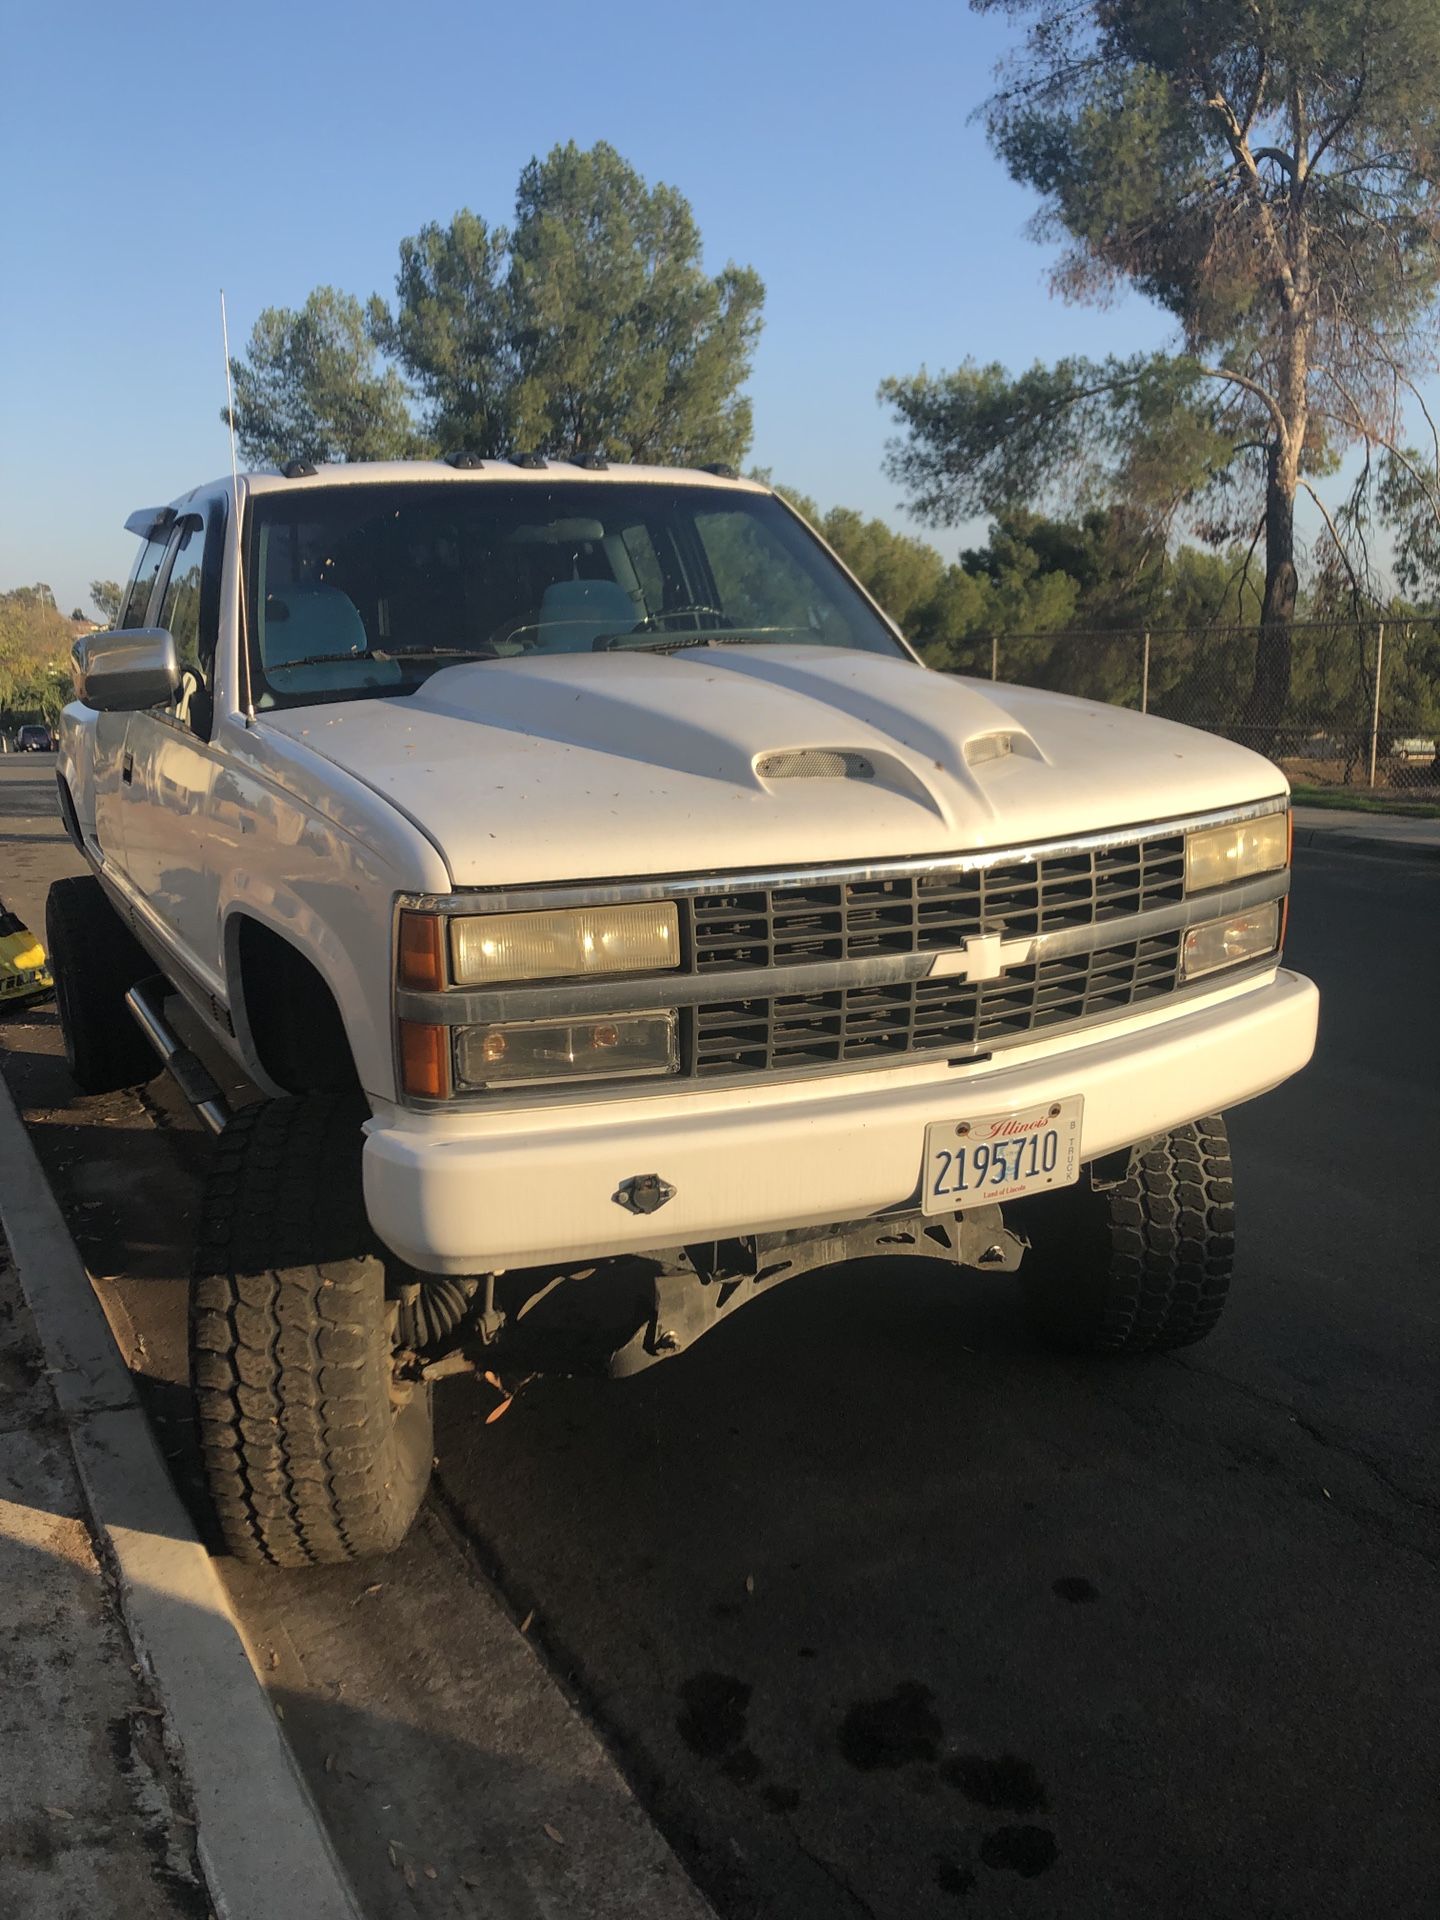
689, 833, 1185, 973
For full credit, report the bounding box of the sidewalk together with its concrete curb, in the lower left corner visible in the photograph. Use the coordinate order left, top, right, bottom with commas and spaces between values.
0, 1081, 366, 1920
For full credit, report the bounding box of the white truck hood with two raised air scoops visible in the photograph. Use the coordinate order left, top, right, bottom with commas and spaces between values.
261, 647, 1284, 887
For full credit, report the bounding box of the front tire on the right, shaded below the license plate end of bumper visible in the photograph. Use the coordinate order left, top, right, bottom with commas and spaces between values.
1020, 1116, 1235, 1354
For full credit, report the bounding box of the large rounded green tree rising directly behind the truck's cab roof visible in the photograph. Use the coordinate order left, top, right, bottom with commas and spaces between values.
378, 142, 764, 465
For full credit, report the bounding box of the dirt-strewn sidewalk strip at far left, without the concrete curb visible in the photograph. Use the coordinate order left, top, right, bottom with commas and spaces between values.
0, 1242, 211, 1920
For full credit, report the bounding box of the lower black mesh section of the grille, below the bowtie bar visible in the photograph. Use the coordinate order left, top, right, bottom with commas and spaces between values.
689, 933, 1181, 1079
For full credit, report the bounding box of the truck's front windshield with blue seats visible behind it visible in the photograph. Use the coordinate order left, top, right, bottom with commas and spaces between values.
248, 480, 904, 707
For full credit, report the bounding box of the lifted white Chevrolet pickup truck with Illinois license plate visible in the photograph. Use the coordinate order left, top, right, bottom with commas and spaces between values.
46, 455, 1317, 1565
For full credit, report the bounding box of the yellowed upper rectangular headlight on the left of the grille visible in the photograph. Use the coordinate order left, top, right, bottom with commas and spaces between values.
449, 900, 680, 987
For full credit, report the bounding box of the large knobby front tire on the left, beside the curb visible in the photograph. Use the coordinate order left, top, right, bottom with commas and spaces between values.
190, 1094, 434, 1567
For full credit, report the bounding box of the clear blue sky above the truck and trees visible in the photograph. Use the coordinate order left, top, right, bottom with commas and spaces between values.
0, 0, 1165, 612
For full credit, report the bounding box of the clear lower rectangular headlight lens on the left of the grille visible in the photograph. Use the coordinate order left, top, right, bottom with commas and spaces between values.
455, 1008, 680, 1087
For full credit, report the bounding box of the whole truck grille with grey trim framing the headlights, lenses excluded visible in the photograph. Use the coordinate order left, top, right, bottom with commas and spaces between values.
394, 795, 1290, 1110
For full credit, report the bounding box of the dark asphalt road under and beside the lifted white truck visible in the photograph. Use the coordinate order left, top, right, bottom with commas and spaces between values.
0, 762, 1440, 1920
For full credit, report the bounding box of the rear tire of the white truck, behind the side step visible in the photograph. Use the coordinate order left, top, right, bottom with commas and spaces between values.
44, 874, 159, 1092
